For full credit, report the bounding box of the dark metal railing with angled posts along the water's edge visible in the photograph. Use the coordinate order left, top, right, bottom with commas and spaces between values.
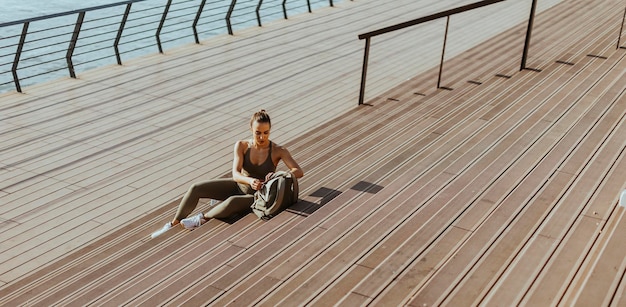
0, 0, 338, 92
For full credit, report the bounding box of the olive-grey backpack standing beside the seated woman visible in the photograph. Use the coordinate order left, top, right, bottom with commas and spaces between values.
251, 171, 299, 220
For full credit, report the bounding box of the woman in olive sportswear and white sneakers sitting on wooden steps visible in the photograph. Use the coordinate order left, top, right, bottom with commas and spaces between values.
152, 110, 304, 238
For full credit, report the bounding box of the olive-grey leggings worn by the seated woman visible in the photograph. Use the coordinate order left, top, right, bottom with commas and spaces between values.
175, 179, 254, 221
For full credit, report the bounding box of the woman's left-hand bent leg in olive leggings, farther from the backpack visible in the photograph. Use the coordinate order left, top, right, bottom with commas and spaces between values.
172, 179, 242, 225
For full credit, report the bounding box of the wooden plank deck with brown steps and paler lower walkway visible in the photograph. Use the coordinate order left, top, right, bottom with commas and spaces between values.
0, 0, 626, 306
